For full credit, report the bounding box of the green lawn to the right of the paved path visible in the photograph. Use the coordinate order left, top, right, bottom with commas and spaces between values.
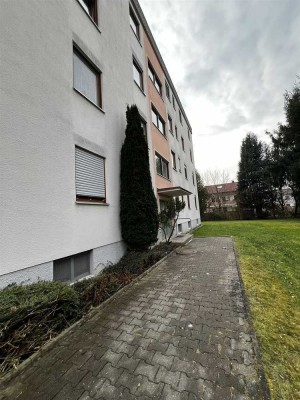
194, 220, 300, 400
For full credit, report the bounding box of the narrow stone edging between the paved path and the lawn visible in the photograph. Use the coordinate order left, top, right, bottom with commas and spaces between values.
230, 236, 271, 400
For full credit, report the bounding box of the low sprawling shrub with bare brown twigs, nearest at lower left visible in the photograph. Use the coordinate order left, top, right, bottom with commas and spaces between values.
0, 282, 82, 373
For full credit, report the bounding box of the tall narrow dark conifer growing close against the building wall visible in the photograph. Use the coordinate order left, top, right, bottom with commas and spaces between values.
120, 105, 158, 249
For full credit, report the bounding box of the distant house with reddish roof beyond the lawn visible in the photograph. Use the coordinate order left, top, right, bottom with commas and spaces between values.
205, 181, 238, 212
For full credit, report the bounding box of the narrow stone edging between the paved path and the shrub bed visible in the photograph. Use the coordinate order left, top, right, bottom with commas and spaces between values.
0, 244, 180, 388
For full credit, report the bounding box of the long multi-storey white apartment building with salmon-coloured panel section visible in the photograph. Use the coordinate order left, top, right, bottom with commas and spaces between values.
0, 0, 200, 287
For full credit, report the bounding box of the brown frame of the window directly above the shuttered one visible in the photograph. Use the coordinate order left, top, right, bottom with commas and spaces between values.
73, 43, 102, 110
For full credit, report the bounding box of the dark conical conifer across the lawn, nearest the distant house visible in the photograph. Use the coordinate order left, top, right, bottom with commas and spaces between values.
238, 133, 269, 218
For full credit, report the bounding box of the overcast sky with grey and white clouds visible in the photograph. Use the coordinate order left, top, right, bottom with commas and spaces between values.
140, 0, 300, 179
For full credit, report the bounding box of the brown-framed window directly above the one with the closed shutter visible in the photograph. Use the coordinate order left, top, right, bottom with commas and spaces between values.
73, 47, 102, 108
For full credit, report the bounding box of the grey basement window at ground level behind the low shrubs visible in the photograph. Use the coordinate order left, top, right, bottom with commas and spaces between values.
53, 251, 90, 282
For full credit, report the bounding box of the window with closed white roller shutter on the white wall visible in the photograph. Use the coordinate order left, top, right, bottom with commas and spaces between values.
75, 146, 105, 203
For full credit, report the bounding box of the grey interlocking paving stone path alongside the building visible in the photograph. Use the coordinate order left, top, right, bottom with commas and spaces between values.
0, 238, 264, 400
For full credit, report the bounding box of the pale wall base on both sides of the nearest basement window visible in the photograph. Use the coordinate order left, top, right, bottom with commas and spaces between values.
0, 242, 126, 289
